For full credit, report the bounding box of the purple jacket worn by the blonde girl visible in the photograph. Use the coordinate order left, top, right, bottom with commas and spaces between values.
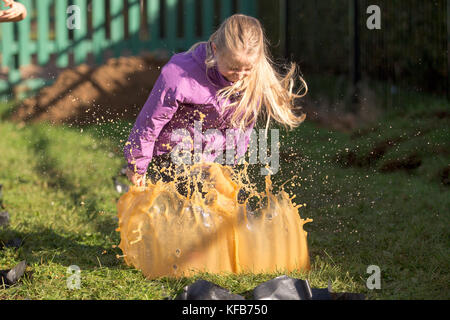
124, 43, 254, 175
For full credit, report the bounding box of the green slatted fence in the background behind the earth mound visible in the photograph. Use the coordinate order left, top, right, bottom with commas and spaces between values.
0, 0, 257, 96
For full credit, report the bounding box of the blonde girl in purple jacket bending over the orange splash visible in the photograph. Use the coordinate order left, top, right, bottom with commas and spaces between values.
124, 14, 307, 190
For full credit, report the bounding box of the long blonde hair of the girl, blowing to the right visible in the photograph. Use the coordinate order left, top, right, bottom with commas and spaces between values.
188, 14, 308, 133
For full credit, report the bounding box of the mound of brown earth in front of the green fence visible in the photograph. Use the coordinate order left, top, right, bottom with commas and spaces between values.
11, 55, 167, 125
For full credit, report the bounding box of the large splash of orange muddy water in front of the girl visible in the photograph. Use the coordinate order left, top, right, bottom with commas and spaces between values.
117, 163, 312, 279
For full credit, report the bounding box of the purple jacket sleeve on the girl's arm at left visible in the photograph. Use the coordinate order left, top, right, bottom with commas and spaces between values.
124, 68, 179, 175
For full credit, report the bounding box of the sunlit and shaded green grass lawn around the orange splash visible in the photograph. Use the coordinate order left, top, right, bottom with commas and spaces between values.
0, 90, 450, 299
